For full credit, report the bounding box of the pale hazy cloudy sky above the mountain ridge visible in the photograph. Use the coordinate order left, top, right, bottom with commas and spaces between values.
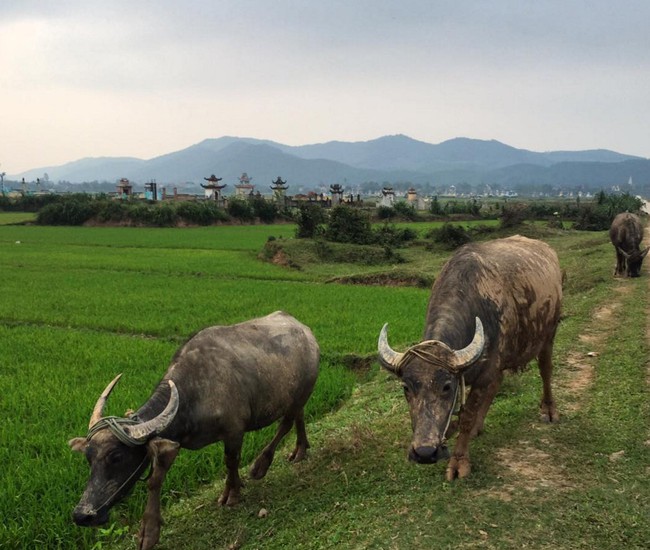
0, 0, 650, 174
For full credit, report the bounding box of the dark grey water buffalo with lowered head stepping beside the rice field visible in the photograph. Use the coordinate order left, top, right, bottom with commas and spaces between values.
69, 311, 320, 549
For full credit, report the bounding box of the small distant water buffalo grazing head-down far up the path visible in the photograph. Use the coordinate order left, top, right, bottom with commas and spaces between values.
609, 212, 650, 277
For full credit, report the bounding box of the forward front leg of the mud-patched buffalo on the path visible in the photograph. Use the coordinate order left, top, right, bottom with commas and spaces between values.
446, 375, 502, 481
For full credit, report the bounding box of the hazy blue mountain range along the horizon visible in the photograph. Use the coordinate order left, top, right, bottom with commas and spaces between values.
11, 135, 650, 193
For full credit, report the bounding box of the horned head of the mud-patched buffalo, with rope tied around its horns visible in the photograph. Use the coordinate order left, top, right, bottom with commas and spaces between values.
378, 317, 485, 464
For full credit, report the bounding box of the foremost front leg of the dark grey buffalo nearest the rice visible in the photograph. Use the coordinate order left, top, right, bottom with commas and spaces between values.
138, 438, 180, 550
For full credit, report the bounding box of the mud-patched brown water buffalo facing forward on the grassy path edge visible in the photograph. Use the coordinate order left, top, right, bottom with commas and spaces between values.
378, 236, 562, 481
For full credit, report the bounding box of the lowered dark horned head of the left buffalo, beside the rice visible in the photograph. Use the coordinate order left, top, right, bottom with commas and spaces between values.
68, 375, 179, 527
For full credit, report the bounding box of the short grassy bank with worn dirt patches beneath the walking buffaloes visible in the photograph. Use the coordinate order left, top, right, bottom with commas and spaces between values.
120, 232, 650, 549
